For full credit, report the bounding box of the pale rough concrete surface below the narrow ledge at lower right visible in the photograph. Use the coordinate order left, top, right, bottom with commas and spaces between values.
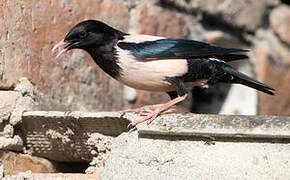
101, 132, 290, 180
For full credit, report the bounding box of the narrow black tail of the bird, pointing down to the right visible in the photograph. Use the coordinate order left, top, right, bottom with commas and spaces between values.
213, 62, 275, 95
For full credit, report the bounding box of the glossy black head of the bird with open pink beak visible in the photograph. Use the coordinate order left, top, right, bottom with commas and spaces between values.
53, 20, 126, 57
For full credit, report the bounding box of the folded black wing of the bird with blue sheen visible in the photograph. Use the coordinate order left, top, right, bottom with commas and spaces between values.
118, 39, 248, 61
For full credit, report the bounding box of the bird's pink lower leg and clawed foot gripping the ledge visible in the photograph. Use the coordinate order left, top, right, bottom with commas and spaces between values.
120, 94, 187, 126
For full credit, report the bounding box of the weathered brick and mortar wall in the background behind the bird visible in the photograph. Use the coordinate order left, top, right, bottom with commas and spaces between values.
0, 0, 290, 115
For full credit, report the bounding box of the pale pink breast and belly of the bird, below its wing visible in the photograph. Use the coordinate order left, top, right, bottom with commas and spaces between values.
116, 47, 187, 91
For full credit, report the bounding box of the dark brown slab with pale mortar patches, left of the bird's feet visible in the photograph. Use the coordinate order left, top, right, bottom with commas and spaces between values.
21, 111, 129, 162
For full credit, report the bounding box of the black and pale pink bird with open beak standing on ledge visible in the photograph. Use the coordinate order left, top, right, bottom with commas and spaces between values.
52, 19, 275, 126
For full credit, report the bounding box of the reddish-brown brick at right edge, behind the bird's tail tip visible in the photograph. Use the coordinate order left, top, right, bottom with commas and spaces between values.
255, 46, 290, 116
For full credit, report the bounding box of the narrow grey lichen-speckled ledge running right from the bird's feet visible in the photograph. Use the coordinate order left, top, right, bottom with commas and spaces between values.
137, 113, 290, 139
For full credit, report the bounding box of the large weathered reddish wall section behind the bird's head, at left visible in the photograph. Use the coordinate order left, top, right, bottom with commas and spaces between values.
0, 0, 130, 111
